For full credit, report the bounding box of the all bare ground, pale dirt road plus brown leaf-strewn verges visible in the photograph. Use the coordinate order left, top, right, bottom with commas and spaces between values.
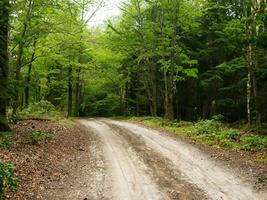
0, 119, 267, 200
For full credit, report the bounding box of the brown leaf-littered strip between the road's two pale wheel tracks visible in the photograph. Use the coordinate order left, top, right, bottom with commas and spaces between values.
105, 122, 208, 200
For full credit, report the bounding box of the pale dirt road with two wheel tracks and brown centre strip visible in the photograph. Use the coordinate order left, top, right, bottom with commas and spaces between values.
80, 119, 267, 200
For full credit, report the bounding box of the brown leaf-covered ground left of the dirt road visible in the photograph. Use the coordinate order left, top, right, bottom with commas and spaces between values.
0, 120, 105, 200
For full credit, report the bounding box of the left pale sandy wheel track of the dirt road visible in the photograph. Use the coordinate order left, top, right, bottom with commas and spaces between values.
82, 120, 165, 200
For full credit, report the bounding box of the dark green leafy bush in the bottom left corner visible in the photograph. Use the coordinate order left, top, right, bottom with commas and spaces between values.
0, 160, 18, 200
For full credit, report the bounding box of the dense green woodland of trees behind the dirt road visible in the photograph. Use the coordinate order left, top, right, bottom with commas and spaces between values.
0, 0, 267, 131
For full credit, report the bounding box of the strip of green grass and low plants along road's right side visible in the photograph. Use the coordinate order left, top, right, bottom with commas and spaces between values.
128, 117, 267, 163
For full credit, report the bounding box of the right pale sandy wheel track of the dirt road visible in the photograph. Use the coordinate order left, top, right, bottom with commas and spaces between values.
102, 119, 267, 200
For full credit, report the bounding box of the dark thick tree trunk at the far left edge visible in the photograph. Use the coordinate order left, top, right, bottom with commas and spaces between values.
0, 0, 10, 131
